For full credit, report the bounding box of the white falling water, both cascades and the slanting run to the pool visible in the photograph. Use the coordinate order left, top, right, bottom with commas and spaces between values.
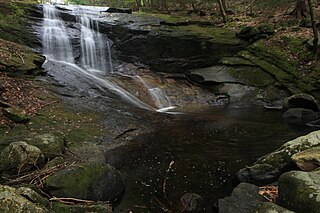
42, 5, 174, 112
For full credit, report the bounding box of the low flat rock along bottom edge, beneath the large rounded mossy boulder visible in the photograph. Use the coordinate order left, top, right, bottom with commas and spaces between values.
52, 202, 113, 213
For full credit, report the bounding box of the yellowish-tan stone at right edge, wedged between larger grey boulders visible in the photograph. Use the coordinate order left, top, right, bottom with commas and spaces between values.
291, 146, 320, 171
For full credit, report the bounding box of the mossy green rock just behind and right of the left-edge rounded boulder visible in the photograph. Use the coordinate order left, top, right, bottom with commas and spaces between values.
26, 132, 64, 159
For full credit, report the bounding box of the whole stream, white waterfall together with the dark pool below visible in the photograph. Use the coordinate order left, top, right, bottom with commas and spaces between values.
35, 5, 299, 212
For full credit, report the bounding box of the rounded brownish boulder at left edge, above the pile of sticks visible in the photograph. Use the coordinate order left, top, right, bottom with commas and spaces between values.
0, 141, 43, 174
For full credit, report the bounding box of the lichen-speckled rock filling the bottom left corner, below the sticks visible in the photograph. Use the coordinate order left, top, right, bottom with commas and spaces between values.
0, 185, 49, 213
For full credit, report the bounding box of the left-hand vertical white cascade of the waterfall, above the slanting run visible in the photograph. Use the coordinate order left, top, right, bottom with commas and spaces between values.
42, 5, 74, 63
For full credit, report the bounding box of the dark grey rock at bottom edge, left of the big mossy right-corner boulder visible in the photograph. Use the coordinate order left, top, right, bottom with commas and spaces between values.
219, 183, 267, 213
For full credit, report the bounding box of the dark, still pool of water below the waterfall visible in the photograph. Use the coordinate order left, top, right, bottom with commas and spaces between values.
107, 109, 304, 212
